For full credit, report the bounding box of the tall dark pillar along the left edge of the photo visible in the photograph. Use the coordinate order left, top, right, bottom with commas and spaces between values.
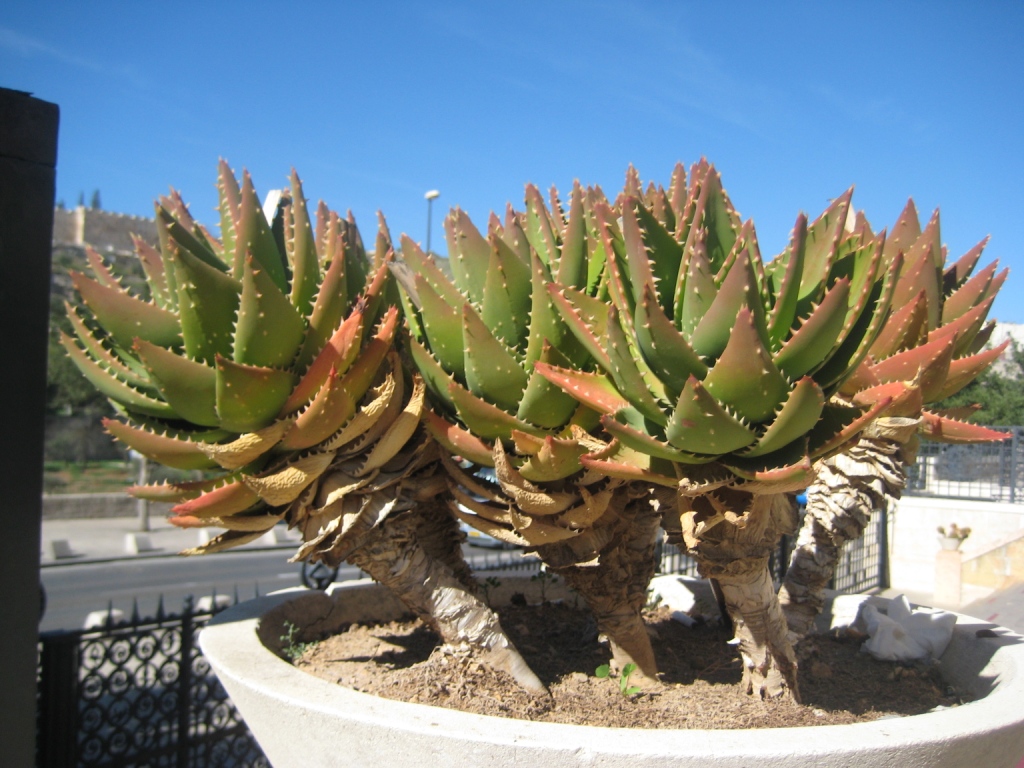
0, 88, 59, 768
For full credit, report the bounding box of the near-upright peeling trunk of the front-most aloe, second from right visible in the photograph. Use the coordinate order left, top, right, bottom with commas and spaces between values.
666, 490, 800, 701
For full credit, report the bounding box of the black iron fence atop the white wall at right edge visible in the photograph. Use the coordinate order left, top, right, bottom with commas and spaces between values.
904, 427, 1024, 504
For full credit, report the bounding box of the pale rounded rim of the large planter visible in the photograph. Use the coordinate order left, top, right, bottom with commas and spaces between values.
200, 580, 1024, 765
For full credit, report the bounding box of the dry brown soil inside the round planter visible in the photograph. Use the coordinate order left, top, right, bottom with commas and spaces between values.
296, 603, 966, 728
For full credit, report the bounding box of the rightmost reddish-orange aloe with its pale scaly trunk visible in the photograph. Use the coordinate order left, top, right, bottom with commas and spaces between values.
780, 200, 1009, 637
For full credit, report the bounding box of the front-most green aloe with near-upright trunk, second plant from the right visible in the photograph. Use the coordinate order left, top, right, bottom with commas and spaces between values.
537, 161, 898, 694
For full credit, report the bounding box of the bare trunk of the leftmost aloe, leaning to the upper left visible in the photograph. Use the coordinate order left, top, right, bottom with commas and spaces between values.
339, 503, 548, 696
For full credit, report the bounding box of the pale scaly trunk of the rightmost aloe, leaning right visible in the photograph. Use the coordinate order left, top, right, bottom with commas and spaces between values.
779, 417, 918, 642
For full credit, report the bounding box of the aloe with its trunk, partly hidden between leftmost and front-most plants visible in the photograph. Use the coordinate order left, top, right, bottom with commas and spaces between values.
387, 183, 658, 676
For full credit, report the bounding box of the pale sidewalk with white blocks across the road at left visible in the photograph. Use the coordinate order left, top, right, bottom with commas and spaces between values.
40, 515, 299, 567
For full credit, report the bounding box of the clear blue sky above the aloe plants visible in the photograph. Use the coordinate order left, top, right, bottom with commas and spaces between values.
6, 0, 1024, 323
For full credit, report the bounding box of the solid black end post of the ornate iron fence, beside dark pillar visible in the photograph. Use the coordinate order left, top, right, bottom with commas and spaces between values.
38, 632, 79, 768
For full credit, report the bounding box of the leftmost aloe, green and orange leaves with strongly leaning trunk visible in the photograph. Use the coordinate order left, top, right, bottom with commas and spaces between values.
63, 163, 545, 693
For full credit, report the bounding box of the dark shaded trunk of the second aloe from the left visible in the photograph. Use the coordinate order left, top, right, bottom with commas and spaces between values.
538, 486, 660, 681
